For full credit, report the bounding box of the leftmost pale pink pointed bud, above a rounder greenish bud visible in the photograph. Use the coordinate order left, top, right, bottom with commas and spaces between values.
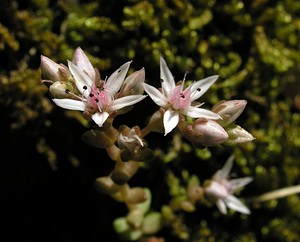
41, 55, 70, 82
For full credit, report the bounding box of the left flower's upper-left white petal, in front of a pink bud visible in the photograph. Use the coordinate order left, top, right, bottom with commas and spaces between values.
68, 61, 93, 97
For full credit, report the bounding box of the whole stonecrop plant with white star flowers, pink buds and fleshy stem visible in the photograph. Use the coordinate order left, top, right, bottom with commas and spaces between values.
41, 47, 254, 240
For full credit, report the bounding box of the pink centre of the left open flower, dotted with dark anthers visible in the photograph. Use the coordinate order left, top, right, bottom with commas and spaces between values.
87, 85, 113, 112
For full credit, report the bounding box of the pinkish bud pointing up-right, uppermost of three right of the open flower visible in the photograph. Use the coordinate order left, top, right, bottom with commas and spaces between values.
212, 100, 247, 126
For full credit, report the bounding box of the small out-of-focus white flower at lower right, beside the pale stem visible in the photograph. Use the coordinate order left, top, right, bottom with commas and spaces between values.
204, 156, 252, 214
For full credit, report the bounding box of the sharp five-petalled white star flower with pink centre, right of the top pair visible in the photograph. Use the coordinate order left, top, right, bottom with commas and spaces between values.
144, 57, 221, 135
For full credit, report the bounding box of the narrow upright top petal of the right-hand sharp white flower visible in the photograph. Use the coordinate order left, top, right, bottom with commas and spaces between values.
160, 57, 175, 96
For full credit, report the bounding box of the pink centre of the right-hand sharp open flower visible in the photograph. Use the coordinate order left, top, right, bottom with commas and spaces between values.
169, 85, 191, 110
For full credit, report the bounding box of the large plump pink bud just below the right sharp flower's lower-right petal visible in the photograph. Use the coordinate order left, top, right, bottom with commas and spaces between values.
181, 118, 228, 146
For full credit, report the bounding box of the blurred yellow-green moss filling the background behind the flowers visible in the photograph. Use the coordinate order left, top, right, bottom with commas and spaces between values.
0, 0, 300, 242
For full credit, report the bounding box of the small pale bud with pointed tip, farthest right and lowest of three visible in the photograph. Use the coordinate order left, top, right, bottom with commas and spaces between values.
226, 125, 255, 145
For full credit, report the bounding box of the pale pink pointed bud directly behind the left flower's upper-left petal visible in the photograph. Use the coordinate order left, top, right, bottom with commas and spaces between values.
72, 47, 96, 80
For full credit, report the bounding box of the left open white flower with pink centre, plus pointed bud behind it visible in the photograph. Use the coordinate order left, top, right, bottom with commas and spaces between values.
49, 48, 146, 127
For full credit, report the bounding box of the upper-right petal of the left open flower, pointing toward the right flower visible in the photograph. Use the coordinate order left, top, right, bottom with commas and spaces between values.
106, 61, 131, 96
